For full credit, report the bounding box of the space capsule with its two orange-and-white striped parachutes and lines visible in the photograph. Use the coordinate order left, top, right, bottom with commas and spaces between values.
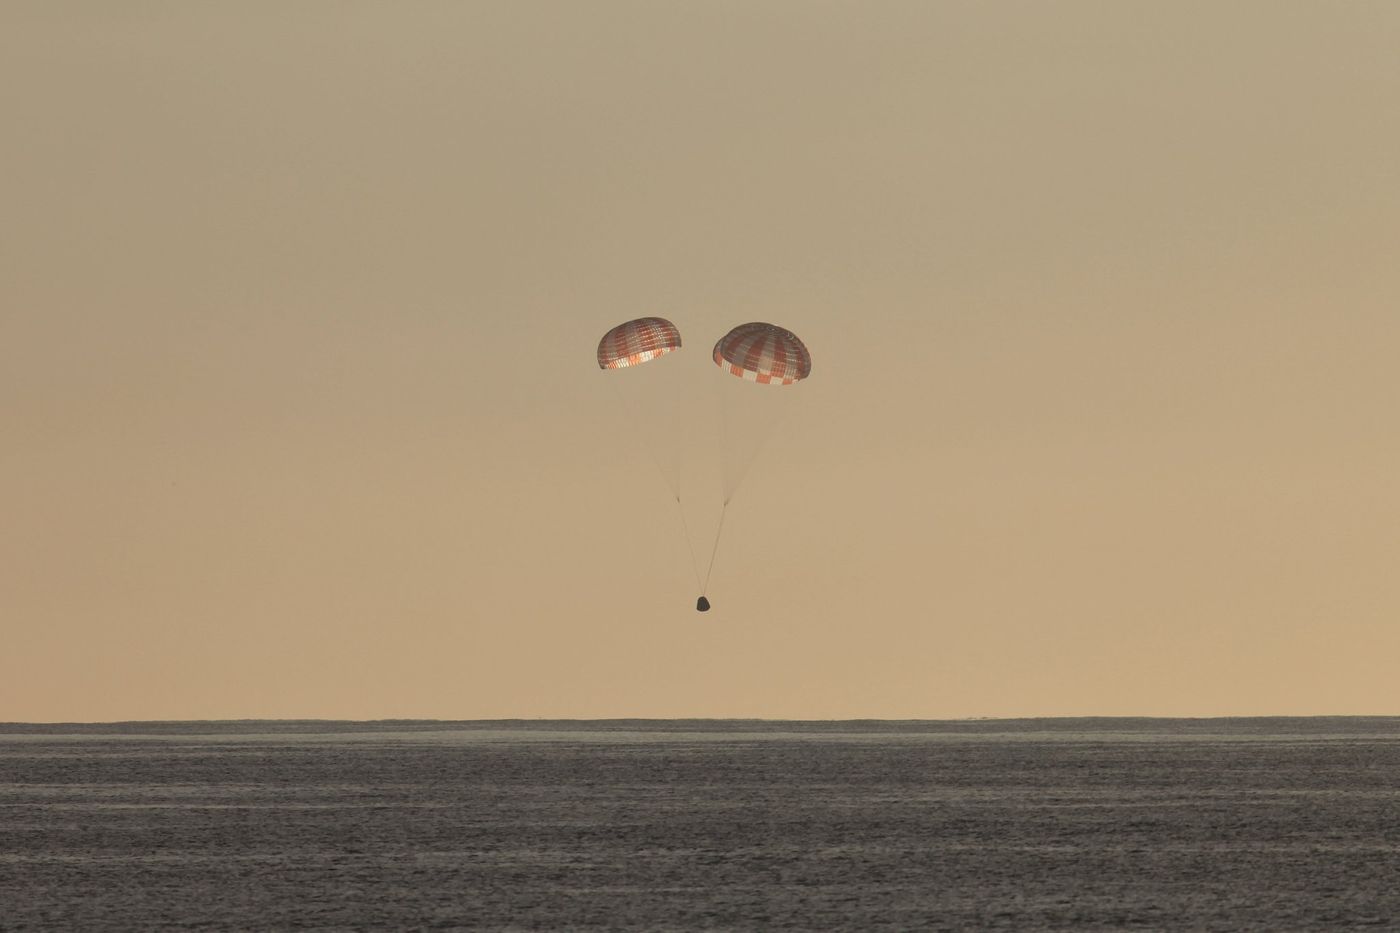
598, 318, 812, 612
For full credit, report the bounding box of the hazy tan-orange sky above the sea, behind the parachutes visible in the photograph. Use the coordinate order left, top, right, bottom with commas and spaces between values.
0, 0, 1400, 721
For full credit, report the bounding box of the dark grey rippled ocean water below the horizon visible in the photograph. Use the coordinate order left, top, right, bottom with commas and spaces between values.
0, 717, 1400, 930
